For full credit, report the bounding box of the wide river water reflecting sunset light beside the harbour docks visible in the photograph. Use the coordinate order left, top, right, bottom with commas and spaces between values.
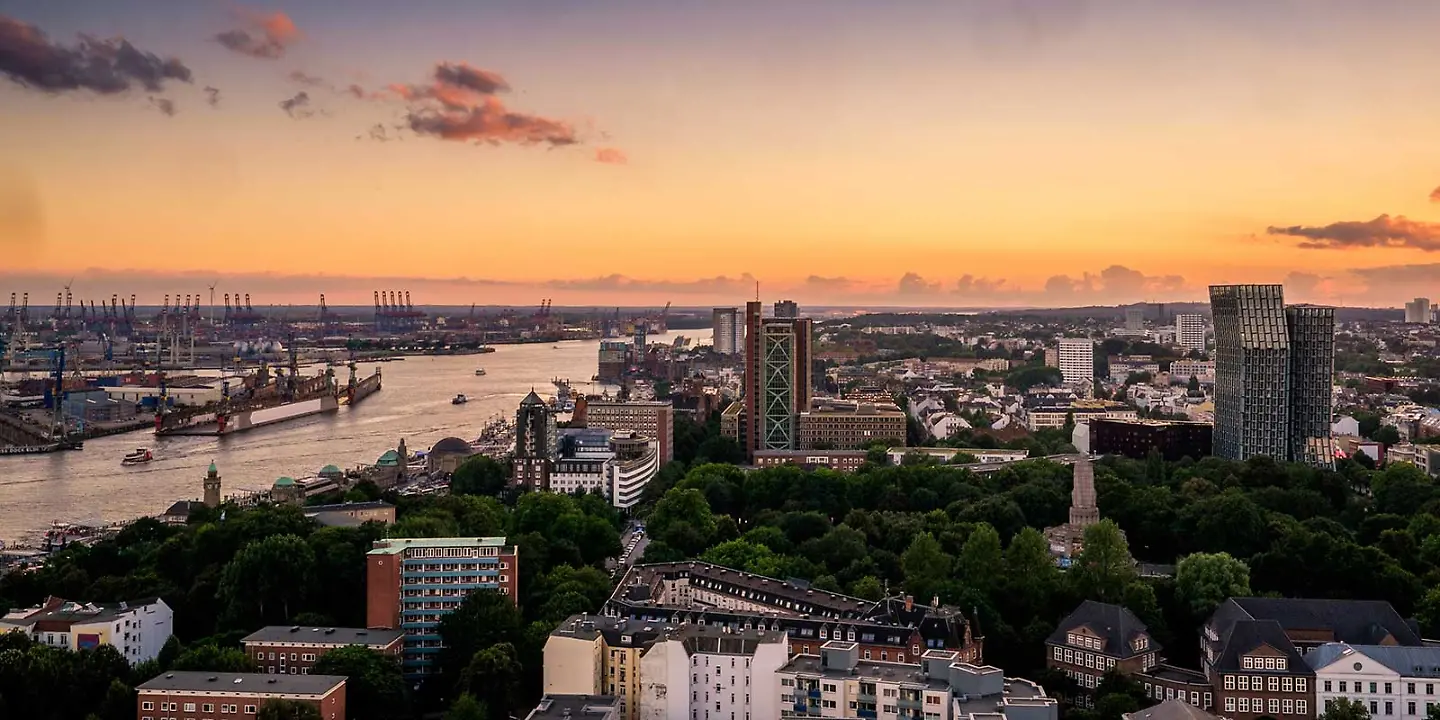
0, 330, 710, 541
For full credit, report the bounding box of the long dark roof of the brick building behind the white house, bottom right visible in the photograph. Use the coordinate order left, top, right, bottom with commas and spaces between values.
1217, 598, 1423, 647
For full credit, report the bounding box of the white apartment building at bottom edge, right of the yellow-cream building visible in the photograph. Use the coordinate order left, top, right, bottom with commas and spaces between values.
636, 625, 789, 720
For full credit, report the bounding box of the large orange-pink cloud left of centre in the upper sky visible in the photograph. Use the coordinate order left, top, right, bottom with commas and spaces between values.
383, 62, 580, 147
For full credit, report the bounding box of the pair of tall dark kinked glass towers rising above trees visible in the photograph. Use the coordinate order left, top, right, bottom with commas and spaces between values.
1210, 285, 1335, 467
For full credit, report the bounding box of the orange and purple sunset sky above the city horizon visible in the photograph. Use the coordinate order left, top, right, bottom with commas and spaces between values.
0, 0, 1440, 307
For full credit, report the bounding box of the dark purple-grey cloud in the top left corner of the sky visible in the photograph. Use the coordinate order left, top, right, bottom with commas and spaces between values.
0, 16, 193, 95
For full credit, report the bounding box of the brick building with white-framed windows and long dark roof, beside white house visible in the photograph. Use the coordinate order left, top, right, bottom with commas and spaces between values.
1201, 598, 1423, 720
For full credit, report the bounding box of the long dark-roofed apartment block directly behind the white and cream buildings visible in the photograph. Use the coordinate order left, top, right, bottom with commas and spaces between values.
605, 560, 985, 662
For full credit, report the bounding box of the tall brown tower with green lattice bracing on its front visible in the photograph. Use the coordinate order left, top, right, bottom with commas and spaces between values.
742, 301, 811, 459
